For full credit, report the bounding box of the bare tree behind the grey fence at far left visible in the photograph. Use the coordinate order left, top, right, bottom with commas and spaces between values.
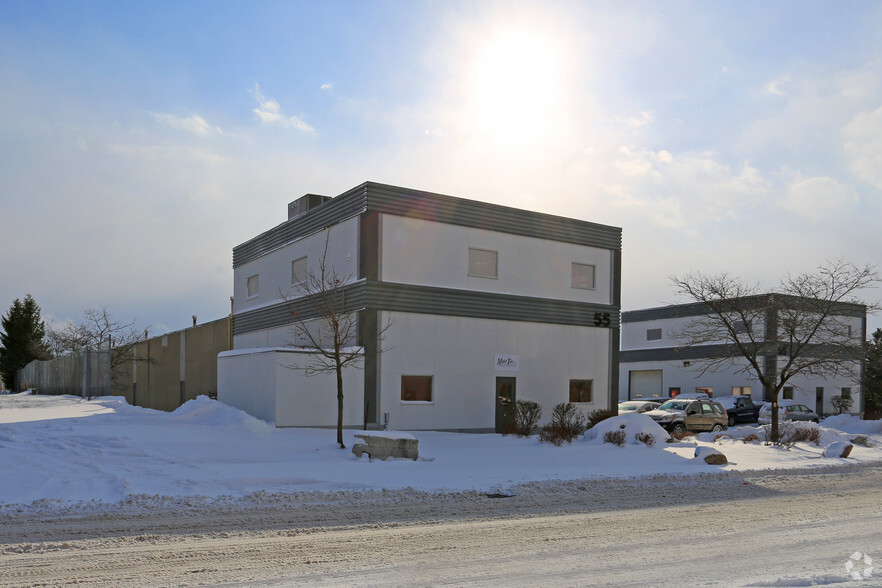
46, 306, 147, 384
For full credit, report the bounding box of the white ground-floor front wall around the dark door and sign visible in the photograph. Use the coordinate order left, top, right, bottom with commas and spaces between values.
380, 313, 610, 430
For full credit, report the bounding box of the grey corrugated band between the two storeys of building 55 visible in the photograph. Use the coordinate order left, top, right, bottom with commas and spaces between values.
233, 282, 620, 335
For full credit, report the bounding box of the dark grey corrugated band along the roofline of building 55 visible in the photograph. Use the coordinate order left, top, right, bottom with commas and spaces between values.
233, 182, 622, 268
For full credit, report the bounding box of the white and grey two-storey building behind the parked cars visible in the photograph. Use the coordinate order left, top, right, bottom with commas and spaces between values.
619, 296, 867, 415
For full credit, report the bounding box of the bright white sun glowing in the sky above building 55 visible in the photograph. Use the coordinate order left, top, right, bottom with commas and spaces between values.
474, 28, 563, 149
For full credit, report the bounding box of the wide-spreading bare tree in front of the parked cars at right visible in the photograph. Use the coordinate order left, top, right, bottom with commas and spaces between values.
670, 260, 880, 442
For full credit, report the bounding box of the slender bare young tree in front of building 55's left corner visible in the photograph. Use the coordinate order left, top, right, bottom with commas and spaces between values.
282, 229, 391, 449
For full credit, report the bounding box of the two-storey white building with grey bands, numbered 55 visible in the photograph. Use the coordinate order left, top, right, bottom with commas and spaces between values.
218, 182, 621, 432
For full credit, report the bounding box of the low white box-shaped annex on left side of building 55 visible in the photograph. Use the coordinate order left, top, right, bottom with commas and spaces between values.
218, 349, 364, 428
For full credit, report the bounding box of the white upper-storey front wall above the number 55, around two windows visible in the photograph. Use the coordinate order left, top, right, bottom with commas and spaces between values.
380, 215, 613, 304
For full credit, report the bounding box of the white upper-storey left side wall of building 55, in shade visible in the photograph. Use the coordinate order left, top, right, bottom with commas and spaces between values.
233, 217, 359, 316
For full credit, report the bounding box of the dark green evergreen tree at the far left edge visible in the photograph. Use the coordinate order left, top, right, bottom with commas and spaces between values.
0, 294, 49, 389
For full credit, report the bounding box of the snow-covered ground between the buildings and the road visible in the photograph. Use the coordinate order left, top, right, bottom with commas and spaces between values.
0, 394, 882, 512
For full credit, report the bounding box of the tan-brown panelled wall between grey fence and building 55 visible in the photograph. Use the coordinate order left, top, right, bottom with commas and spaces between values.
113, 318, 231, 411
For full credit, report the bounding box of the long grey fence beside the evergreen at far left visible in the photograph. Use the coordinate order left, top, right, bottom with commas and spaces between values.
18, 350, 111, 398
